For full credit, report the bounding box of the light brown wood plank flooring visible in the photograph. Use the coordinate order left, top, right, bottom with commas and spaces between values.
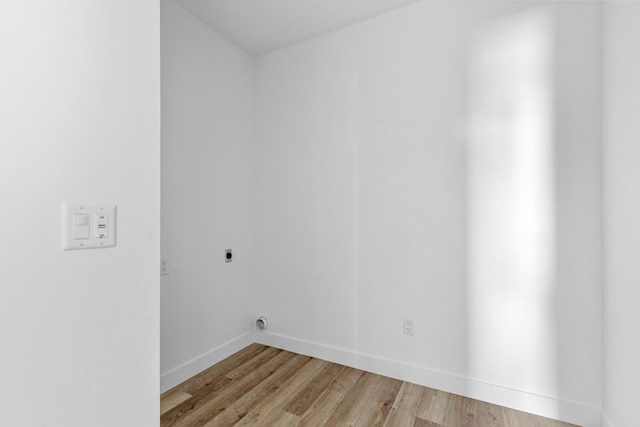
160, 344, 571, 427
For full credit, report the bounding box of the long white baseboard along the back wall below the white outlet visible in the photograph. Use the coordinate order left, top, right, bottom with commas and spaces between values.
253, 330, 600, 427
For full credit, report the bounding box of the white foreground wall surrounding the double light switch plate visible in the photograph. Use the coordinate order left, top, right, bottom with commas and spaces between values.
0, 0, 160, 427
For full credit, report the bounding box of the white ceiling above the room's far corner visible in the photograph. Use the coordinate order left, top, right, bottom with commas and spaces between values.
172, 0, 419, 56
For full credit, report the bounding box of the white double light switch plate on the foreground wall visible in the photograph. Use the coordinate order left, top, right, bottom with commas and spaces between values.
62, 203, 116, 251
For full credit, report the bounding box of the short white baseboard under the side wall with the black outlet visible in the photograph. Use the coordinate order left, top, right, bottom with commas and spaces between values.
160, 332, 253, 393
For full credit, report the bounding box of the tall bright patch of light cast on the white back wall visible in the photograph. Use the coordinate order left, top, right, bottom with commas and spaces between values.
467, 8, 560, 417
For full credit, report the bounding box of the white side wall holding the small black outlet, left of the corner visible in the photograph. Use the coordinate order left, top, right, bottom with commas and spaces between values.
161, 0, 253, 390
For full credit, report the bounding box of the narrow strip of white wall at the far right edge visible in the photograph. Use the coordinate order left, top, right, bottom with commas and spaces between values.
603, 2, 640, 427
